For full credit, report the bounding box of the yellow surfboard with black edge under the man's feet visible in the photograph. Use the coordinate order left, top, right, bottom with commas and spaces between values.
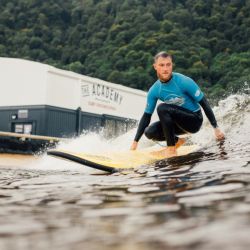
47, 145, 198, 173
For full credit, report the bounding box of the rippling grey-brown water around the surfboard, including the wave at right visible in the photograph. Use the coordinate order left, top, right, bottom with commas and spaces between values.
0, 95, 250, 250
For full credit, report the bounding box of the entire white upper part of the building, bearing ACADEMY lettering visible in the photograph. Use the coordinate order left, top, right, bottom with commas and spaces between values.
0, 57, 146, 119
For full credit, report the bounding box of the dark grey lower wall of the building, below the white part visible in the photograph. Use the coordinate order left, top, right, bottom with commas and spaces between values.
0, 105, 136, 138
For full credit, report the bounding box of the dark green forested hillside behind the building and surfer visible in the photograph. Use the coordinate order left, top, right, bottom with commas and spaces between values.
0, 0, 250, 96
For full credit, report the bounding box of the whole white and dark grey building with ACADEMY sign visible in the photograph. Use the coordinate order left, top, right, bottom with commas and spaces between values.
0, 57, 146, 137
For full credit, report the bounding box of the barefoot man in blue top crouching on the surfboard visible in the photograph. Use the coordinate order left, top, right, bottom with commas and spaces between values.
130, 51, 225, 157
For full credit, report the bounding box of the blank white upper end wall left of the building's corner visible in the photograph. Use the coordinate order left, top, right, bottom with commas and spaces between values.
0, 58, 48, 107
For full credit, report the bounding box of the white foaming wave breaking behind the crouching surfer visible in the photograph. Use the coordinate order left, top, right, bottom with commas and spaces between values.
52, 94, 250, 153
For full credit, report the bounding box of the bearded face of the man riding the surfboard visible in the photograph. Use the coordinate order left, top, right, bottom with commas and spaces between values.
154, 57, 173, 82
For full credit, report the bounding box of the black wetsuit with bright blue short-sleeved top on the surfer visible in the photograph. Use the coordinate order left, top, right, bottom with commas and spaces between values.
134, 72, 217, 146
